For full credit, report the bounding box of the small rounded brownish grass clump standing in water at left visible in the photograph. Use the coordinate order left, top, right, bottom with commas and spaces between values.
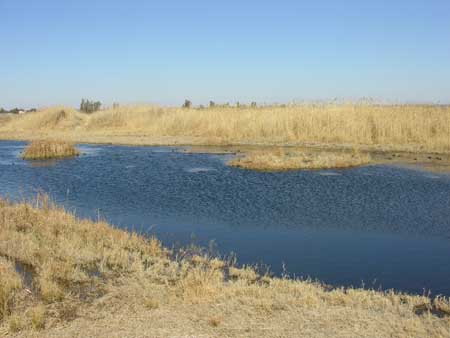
22, 140, 80, 160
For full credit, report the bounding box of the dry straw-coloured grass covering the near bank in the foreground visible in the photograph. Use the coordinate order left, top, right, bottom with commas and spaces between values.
0, 196, 450, 338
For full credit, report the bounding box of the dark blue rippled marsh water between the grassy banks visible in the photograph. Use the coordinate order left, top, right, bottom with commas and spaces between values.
0, 141, 450, 296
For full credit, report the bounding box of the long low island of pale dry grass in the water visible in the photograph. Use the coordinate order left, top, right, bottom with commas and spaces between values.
227, 148, 371, 171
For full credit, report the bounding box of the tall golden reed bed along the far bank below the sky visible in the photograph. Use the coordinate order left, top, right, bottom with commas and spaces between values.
0, 104, 450, 152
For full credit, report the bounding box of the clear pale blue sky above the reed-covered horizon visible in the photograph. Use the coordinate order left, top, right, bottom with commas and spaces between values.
0, 0, 450, 108
